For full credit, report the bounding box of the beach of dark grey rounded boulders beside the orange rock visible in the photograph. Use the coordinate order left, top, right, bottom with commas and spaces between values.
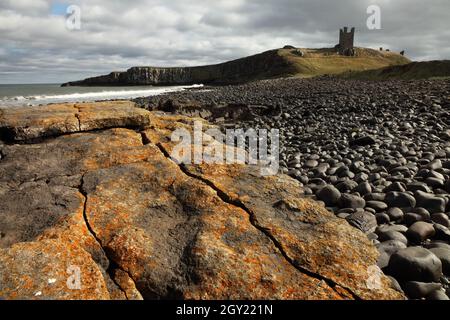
136, 77, 450, 299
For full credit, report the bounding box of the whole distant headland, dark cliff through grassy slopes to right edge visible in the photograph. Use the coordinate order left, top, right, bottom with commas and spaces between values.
62, 47, 450, 86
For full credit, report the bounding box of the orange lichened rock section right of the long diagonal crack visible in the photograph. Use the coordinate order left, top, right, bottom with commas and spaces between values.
144, 116, 399, 299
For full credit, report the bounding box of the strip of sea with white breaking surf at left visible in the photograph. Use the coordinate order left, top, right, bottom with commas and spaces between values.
0, 84, 202, 108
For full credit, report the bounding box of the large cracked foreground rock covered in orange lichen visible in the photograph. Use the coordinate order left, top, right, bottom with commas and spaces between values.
0, 102, 403, 299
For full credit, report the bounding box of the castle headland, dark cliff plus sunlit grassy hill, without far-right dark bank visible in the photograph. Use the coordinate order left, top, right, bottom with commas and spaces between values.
62, 48, 410, 86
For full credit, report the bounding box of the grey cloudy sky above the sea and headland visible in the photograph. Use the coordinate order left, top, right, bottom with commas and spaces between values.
0, 0, 450, 83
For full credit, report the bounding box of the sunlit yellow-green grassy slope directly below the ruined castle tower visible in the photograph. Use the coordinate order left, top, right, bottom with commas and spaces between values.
278, 48, 411, 78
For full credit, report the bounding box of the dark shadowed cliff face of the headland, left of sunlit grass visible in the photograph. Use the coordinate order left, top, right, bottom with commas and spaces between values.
63, 50, 295, 86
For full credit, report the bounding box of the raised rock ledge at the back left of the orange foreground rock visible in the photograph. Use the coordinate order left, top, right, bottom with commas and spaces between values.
0, 101, 149, 141
